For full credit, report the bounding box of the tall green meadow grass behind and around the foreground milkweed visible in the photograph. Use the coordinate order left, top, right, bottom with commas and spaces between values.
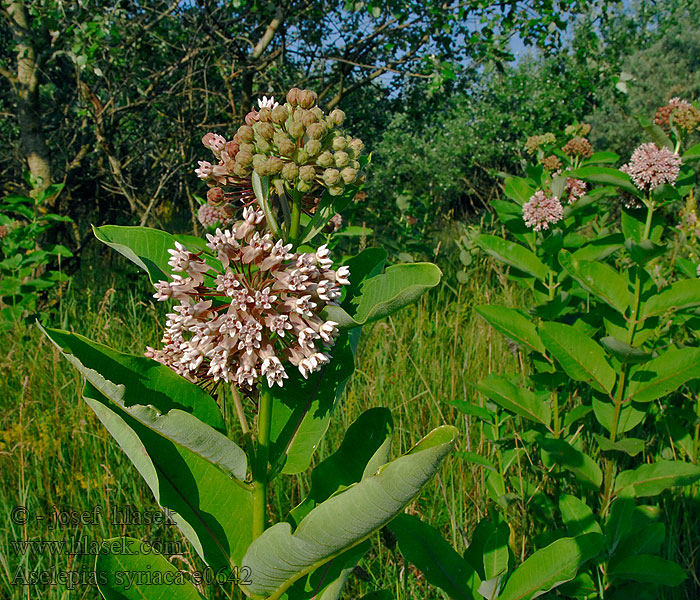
0, 244, 700, 600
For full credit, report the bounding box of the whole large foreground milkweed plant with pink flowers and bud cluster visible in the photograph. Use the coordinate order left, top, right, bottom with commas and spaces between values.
45, 88, 456, 600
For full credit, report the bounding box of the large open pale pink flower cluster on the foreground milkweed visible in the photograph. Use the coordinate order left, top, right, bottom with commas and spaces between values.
146, 208, 350, 388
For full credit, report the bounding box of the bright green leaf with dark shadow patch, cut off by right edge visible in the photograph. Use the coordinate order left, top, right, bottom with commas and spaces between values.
627, 348, 700, 402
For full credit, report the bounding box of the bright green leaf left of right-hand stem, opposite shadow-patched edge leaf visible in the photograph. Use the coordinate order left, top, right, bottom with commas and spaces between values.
540, 323, 616, 394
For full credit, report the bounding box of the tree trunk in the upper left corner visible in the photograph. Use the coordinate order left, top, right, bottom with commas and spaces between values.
7, 0, 55, 200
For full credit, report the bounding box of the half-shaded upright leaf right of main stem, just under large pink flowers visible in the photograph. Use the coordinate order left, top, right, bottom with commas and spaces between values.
270, 330, 359, 474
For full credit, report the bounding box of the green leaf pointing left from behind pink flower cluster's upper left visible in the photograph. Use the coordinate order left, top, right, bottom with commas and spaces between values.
92, 225, 216, 283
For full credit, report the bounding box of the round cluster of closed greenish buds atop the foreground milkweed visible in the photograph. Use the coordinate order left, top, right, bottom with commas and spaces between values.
226, 88, 364, 195
